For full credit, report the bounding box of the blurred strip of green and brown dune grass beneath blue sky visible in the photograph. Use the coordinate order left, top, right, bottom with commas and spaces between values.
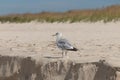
0, 5, 120, 23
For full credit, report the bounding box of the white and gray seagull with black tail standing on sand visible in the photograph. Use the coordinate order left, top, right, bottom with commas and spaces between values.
53, 32, 78, 57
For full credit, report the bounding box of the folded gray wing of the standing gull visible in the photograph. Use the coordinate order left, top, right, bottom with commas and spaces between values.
57, 39, 73, 50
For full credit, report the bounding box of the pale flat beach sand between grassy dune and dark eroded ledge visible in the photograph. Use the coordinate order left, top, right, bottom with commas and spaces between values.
0, 22, 120, 67
